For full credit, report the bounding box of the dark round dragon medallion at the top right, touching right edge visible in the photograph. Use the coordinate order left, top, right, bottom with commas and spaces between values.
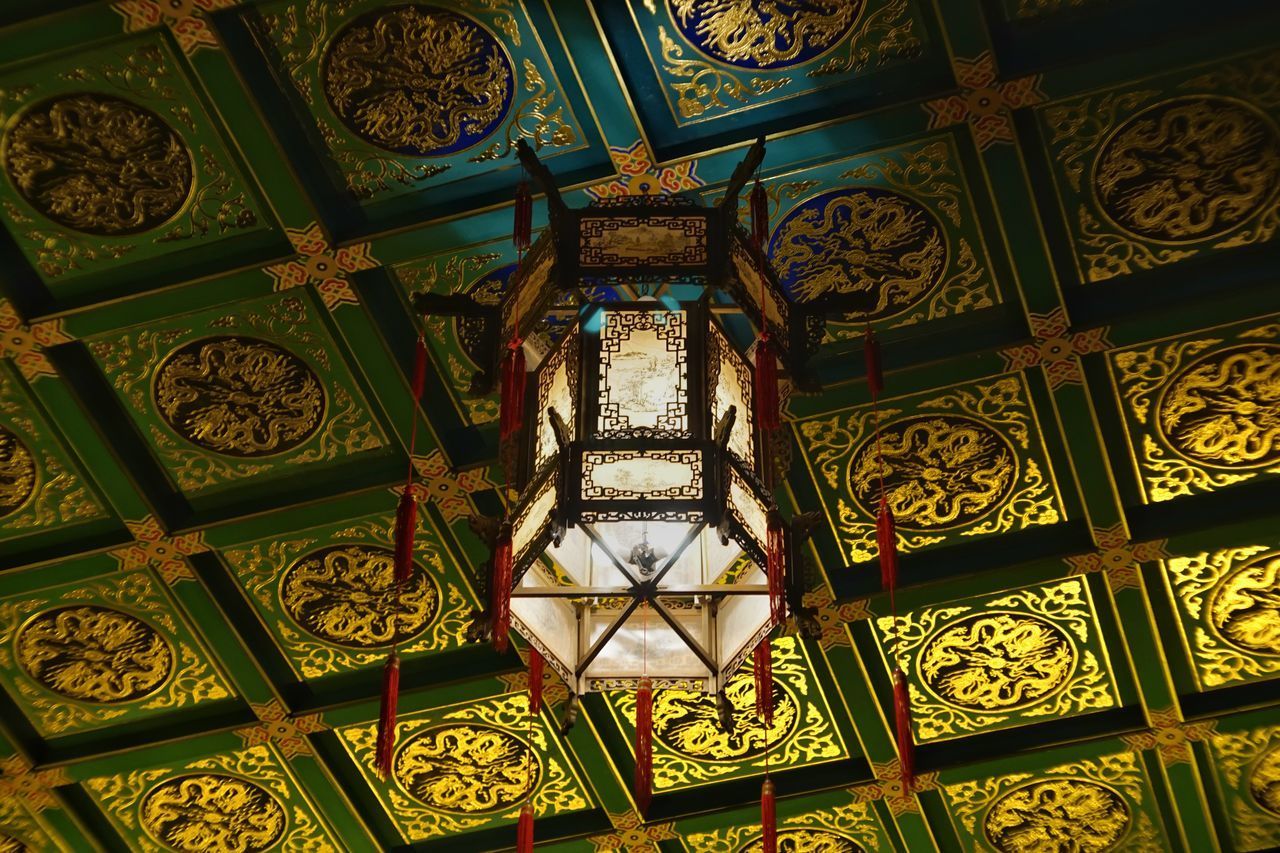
1093, 95, 1280, 243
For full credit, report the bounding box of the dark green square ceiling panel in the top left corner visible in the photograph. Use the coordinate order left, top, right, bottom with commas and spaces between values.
0, 32, 271, 296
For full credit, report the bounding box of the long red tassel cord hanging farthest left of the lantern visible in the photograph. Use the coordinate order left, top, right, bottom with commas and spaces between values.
374, 334, 426, 779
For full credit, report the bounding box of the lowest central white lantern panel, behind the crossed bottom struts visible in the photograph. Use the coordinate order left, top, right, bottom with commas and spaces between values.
585, 607, 710, 689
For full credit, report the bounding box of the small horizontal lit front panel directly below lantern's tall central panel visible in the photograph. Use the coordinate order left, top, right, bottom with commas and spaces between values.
582, 450, 703, 501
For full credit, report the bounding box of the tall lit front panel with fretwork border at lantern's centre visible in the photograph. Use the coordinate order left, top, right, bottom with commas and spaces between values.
596, 310, 690, 437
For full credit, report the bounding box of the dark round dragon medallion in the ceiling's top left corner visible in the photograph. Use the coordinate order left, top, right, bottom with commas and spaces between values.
4, 92, 195, 237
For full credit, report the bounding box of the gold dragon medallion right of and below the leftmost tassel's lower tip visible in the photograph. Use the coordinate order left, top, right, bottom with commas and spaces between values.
394, 722, 543, 815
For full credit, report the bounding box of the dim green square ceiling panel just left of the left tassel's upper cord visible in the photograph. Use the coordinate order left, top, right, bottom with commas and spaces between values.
88, 292, 387, 496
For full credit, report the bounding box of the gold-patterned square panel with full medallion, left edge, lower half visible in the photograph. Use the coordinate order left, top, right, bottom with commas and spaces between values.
0, 570, 232, 736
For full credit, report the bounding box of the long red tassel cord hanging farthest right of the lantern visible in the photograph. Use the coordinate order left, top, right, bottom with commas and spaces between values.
863, 323, 915, 795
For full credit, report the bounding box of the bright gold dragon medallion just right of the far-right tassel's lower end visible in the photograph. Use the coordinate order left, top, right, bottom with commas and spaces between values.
919, 612, 1076, 711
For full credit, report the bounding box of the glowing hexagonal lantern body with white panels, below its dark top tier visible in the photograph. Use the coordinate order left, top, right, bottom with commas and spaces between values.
511, 302, 769, 692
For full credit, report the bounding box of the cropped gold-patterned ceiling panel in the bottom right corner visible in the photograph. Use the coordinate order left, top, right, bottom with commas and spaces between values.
1208, 726, 1280, 850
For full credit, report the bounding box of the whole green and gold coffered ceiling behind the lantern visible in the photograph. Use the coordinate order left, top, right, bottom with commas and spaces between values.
0, 0, 1280, 853
